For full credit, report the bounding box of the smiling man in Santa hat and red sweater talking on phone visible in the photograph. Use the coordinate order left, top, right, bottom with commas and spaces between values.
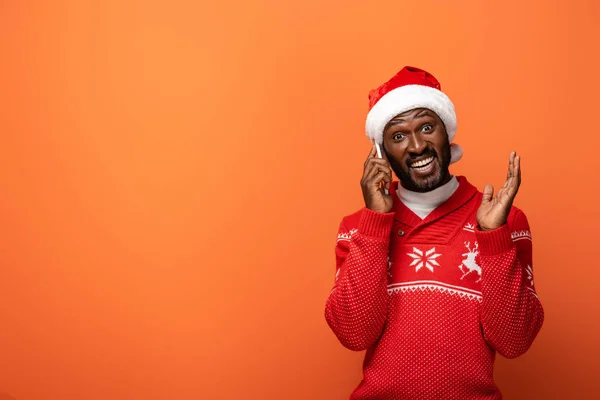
325, 67, 544, 400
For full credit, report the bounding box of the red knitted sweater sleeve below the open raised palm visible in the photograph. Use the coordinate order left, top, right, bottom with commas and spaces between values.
475, 210, 544, 358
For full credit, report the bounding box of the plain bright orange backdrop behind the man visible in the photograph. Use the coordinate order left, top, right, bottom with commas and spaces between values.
0, 0, 600, 400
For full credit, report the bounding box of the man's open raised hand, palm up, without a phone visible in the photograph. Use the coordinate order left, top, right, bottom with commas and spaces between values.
477, 151, 521, 231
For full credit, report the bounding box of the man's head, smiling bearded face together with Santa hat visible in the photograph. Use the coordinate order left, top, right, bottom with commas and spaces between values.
366, 67, 462, 191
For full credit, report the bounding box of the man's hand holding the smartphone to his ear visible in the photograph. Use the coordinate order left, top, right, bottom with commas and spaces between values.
360, 145, 393, 213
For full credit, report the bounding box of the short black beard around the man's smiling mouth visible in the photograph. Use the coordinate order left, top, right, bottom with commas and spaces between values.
383, 143, 451, 192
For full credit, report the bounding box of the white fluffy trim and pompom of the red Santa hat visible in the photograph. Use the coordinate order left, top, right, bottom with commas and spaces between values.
366, 85, 462, 162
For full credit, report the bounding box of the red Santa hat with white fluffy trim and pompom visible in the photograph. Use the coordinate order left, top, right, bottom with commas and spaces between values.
366, 67, 462, 163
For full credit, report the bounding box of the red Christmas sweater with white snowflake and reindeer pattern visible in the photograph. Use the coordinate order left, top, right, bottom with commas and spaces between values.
325, 176, 544, 400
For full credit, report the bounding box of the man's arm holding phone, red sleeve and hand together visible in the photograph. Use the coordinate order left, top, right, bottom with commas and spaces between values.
325, 144, 395, 350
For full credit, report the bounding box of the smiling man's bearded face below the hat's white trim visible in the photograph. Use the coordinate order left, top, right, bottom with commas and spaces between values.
383, 108, 451, 192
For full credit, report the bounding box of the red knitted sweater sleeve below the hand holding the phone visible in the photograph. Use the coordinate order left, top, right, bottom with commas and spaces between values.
325, 208, 394, 351
